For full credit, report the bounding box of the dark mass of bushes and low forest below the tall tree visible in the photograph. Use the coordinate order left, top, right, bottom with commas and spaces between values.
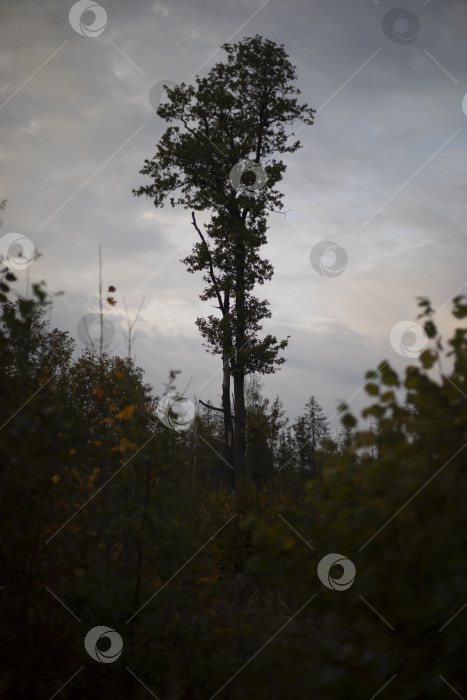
0, 200, 467, 700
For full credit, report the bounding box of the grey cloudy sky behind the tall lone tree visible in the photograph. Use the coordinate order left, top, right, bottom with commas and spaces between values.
0, 0, 467, 425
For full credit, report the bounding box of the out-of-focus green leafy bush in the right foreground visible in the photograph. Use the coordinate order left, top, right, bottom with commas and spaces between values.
249, 297, 467, 700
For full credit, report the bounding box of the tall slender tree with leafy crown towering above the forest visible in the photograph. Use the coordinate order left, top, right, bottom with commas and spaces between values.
134, 35, 315, 485
